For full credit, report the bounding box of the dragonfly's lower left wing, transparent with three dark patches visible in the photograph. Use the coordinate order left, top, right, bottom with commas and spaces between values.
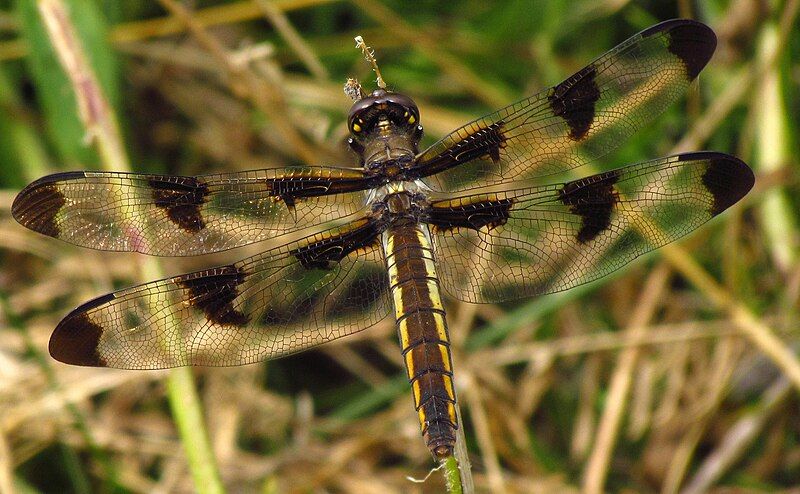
50, 219, 390, 369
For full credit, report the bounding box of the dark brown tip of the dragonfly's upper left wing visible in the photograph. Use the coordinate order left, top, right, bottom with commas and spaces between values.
11, 172, 84, 237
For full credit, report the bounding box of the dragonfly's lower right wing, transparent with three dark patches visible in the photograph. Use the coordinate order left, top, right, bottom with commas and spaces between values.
428, 152, 754, 302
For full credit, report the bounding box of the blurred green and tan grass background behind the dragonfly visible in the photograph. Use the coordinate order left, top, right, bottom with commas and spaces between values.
0, 0, 800, 493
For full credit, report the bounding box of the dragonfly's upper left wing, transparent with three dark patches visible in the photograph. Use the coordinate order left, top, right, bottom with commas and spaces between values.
12, 167, 370, 256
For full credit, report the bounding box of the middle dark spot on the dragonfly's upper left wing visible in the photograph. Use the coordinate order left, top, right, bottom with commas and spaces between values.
149, 177, 208, 233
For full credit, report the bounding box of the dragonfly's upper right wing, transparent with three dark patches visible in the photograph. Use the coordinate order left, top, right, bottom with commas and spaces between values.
415, 19, 716, 192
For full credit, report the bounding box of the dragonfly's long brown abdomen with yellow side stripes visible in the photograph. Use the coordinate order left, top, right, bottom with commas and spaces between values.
384, 224, 458, 458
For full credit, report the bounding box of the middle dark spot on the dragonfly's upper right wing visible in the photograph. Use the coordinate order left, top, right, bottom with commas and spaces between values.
548, 65, 600, 141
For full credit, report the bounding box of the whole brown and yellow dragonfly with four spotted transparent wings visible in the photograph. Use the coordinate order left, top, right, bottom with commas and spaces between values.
12, 19, 754, 460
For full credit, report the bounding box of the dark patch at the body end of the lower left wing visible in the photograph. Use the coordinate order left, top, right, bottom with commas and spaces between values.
290, 220, 383, 269
